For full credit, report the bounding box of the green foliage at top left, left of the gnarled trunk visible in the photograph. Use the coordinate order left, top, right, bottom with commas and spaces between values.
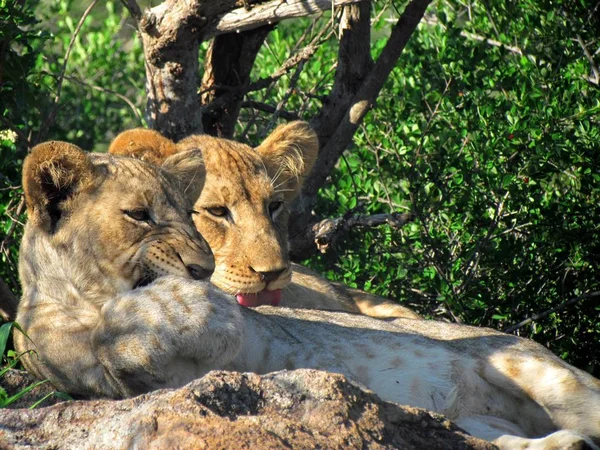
0, 0, 145, 293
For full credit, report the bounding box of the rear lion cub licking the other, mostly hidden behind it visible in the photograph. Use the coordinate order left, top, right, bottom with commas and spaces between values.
109, 122, 420, 318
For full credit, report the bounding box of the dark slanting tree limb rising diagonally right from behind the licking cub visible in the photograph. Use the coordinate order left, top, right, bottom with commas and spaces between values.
290, 0, 431, 239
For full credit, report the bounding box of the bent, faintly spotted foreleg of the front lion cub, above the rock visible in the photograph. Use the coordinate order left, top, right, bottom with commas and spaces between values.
91, 276, 244, 397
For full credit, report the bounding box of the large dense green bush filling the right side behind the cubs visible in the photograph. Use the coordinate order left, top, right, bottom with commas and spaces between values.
311, 1, 600, 375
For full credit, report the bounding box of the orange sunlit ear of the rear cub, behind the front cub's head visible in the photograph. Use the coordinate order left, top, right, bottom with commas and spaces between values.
108, 128, 177, 165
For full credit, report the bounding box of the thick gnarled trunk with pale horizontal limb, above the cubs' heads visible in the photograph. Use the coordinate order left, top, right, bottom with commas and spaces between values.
137, 0, 366, 140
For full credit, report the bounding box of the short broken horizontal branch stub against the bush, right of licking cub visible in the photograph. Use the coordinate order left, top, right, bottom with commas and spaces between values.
290, 211, 414, 261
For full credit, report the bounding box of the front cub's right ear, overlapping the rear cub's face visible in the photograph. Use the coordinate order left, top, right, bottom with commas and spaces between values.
162, 149, 206, 204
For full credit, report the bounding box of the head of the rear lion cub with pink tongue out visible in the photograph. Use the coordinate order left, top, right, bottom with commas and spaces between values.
111, 122, 319, 306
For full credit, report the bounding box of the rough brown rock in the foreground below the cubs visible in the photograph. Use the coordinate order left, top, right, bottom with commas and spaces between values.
0, 370, 496, 450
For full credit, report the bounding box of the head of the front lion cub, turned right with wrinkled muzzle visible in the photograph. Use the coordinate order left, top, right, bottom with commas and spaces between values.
20, 141, 214, 302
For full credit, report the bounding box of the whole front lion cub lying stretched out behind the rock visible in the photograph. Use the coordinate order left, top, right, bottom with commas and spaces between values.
15, 142, 600, 449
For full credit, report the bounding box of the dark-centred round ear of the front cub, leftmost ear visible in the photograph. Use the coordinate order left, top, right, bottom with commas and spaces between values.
23, 141, 94, 233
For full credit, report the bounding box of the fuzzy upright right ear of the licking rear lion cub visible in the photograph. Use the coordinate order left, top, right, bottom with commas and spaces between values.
256, 121, 319, 201
